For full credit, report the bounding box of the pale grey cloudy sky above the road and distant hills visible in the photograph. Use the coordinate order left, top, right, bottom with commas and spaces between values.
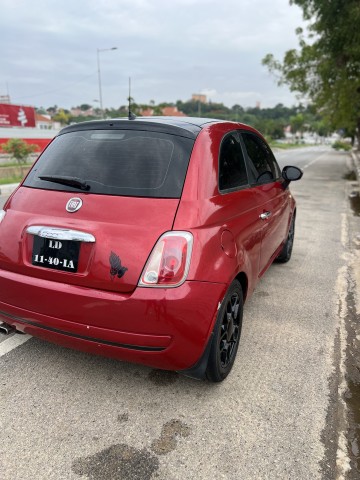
0, 0, 304, 108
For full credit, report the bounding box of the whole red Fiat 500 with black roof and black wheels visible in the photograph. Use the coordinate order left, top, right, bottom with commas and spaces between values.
0, 117, 302, 381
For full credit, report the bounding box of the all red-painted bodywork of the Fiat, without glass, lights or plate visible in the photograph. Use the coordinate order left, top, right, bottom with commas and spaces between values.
0, 118, 295, 370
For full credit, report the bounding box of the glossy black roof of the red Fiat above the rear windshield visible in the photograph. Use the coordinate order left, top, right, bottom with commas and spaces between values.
59, 117, 222, 139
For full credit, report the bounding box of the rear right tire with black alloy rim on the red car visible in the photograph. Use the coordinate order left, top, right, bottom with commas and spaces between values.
206, 280, 243, 382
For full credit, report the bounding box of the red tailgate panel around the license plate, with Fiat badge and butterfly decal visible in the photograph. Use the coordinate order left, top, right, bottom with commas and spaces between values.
0, 187, 179, 292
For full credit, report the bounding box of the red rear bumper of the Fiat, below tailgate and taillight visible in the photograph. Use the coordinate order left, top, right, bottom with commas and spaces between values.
0, 270, 226, 370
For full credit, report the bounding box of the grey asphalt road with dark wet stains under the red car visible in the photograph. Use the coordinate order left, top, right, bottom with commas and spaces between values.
0, 147, 356, 480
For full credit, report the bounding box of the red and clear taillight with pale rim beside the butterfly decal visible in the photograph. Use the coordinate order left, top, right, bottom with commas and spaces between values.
138, 232, 193, 287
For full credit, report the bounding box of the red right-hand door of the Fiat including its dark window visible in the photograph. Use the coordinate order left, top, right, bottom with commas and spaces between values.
241, 132, 290, 276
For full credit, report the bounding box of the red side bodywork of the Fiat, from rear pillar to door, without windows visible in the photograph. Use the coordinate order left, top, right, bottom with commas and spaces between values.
174, 123, 295, 293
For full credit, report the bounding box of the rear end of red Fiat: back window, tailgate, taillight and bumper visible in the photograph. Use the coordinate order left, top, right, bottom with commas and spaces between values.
0, 120, 224, 370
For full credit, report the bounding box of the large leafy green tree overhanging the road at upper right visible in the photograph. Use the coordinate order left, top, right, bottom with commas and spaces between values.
262, 0, 360, 148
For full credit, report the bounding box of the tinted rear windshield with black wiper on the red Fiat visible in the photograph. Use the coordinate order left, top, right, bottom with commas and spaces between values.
24, 130, 194, 198
